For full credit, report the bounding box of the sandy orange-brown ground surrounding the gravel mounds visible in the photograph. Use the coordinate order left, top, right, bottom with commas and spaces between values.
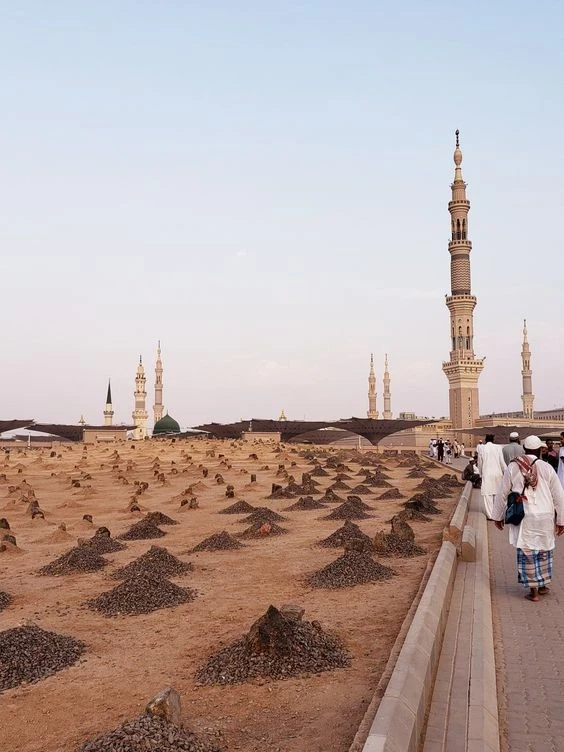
0, 441, 457, 752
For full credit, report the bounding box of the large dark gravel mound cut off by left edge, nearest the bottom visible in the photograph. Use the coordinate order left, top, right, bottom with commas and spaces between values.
0, 626, 86, 691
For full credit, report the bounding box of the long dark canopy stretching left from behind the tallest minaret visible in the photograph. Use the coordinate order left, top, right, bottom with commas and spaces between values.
194, 418, 436, 444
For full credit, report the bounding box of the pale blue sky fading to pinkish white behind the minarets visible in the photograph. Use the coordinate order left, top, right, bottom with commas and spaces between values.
0, 0, 564, 426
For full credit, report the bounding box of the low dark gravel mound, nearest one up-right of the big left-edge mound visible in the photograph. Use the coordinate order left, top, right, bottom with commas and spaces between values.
86, 574, 196, 616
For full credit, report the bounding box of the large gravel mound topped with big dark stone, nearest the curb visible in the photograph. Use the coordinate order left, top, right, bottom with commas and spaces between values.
196, 606, 350, 684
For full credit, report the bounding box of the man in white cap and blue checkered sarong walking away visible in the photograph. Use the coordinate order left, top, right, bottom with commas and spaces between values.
492, 436, 564, 602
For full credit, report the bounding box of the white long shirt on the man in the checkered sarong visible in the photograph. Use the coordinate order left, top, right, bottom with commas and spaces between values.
492, 454, 564, 551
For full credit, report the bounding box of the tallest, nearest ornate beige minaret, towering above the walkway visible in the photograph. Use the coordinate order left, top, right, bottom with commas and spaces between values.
443, 131, 484, 429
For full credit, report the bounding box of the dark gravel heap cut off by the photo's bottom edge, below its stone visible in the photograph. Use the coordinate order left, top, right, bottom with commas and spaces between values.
78, 713, 221, 752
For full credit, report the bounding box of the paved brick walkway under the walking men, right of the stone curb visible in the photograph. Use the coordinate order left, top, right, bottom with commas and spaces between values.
488, 523, 564, 752
